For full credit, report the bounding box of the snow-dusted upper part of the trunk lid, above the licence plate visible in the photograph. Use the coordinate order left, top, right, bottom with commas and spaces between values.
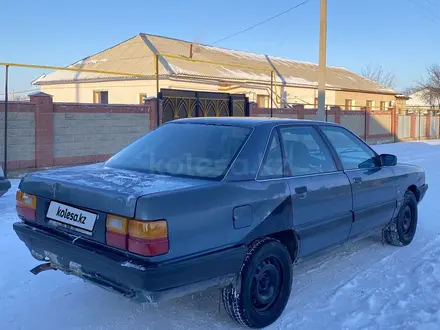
19, 164, 211, 217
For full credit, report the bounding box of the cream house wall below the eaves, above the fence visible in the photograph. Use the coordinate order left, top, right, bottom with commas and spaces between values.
41, 79, 368, 108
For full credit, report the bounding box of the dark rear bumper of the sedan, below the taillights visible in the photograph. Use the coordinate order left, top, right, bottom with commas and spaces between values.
14, 222, 247, 301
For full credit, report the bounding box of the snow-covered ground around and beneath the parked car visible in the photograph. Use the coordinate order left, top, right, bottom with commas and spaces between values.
0, 141, 440, 330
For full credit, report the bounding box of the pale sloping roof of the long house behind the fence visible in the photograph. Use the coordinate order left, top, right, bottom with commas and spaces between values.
34, 34, 398, 94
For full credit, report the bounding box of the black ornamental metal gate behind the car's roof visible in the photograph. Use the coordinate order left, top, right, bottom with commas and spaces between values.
158, 89, 249, 123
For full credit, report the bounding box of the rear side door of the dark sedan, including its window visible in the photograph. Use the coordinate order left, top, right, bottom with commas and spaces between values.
279, 125, 353, 257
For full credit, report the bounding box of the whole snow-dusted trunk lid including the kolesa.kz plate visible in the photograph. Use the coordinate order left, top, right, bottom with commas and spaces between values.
19, 164, 209, 243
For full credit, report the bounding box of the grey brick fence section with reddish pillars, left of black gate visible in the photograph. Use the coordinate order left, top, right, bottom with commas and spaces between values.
0, 93, 157, 170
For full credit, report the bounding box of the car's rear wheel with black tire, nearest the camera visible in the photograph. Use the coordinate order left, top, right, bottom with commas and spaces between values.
222, 238, 292, 328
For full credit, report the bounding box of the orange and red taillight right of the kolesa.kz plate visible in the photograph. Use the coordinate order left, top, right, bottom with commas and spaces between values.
106, 214, 169, 257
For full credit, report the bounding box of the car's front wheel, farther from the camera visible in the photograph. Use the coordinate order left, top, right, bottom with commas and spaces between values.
384, 190, 418, 246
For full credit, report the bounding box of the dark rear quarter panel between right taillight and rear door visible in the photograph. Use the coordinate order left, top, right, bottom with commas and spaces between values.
136, 180, 292, 259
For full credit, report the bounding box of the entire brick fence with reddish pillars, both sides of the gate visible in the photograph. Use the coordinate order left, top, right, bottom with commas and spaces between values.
0, 93, 440, 170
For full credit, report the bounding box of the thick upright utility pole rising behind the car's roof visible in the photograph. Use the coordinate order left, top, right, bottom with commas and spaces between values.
316, 0, 327, 121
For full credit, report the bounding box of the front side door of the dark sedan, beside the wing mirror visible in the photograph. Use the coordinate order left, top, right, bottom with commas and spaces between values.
321, 125, 396, 237
